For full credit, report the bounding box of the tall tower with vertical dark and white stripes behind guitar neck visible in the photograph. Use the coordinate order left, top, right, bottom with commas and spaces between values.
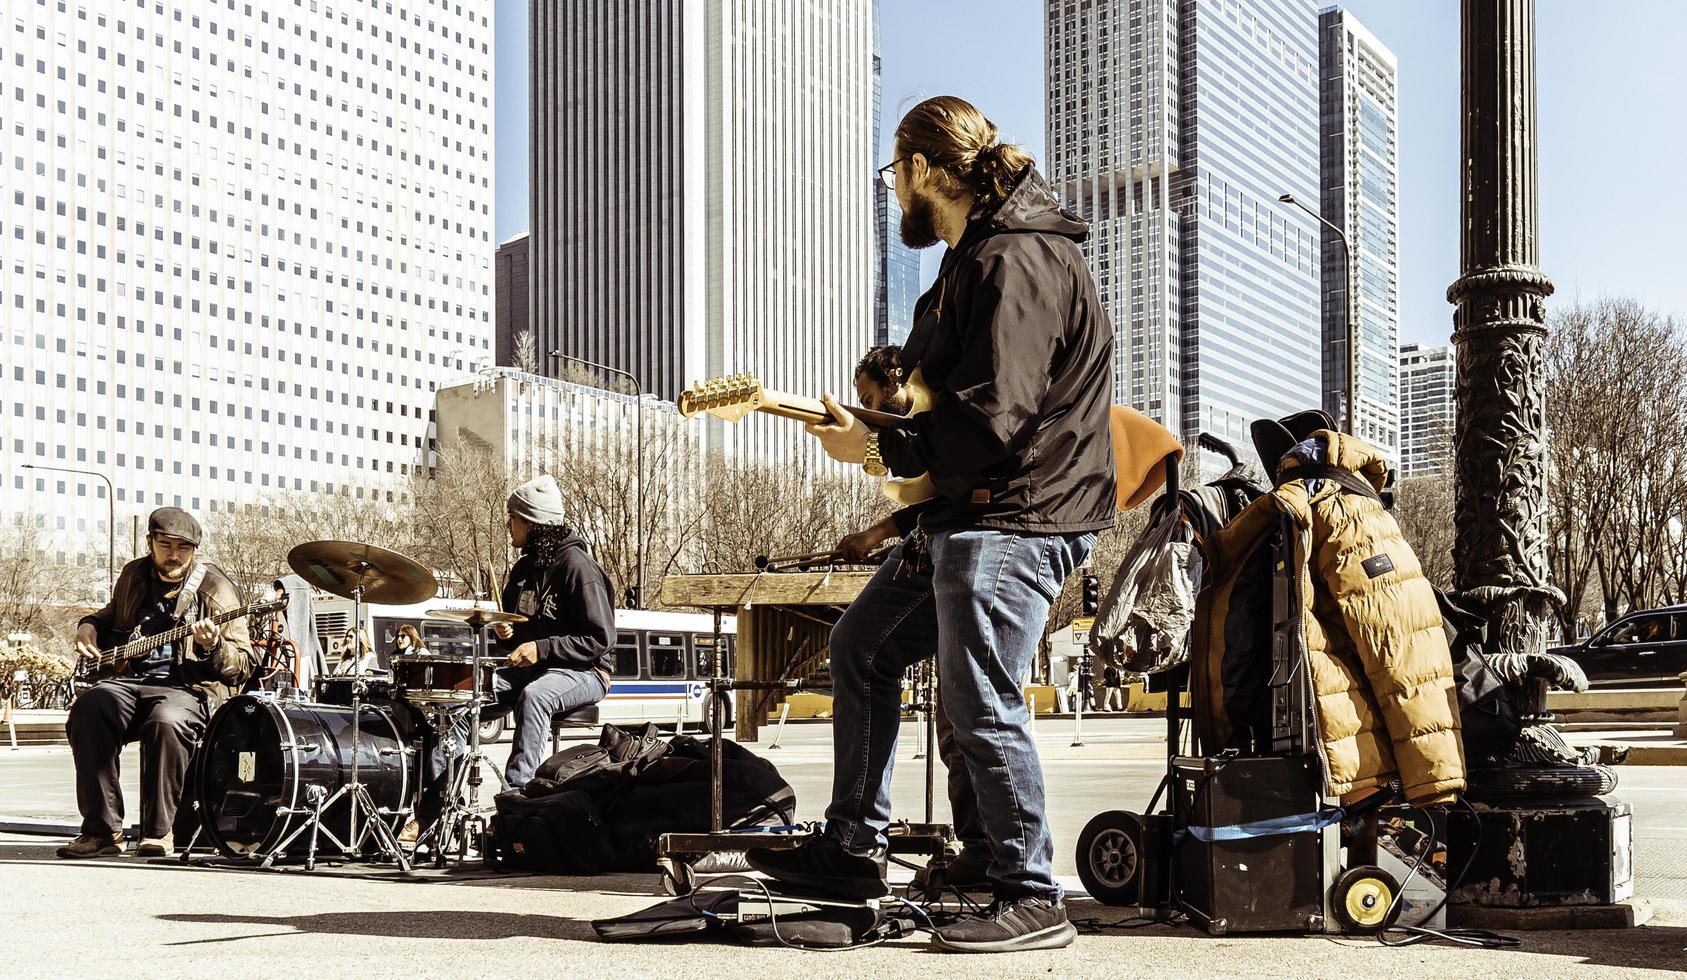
530, 0, 876, 457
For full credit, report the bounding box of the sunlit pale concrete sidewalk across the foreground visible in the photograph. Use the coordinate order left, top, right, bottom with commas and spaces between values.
0, 837, 1687, 980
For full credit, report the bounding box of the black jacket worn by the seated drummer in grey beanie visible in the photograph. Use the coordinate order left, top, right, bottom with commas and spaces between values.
498, 535, 616, 670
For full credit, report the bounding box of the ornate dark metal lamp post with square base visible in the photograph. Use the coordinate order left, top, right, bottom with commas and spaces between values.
1447, 0, 1635, 928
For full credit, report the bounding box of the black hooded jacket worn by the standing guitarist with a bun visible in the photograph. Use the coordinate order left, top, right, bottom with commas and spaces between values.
879, 167, 1113, 533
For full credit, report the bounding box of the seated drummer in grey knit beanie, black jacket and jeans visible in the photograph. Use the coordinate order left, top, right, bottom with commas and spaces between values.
481, 476, 616, 788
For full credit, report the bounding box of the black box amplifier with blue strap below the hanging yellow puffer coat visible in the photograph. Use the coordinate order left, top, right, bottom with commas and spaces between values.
1172, 756, 1339, 936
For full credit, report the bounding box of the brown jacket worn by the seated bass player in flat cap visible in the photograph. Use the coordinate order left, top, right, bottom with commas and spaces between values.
81, 555, 253, 698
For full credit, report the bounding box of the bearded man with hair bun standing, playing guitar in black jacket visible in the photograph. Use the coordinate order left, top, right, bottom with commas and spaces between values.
747, 96, 1113, 953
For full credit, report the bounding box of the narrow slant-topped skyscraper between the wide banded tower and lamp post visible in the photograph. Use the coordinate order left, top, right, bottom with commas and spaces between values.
1318, 7, 1400, 455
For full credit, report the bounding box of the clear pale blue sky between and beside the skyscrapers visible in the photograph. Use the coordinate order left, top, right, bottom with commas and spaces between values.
496, 0, 1687, 344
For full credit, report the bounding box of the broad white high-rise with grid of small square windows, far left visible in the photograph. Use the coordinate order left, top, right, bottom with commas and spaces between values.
0, 0, 493, 555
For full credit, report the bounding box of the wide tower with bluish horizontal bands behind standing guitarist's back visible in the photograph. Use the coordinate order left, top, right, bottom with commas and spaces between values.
1044, 0, 1321, 445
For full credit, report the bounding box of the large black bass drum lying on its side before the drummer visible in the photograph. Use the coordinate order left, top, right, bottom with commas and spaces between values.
196, 695, 410, 857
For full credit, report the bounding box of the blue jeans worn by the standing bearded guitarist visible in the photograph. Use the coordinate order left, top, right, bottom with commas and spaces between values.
827, 528, 1095, 901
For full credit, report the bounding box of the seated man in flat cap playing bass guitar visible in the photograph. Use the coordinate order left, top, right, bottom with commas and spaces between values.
59, 508, 253, 859
